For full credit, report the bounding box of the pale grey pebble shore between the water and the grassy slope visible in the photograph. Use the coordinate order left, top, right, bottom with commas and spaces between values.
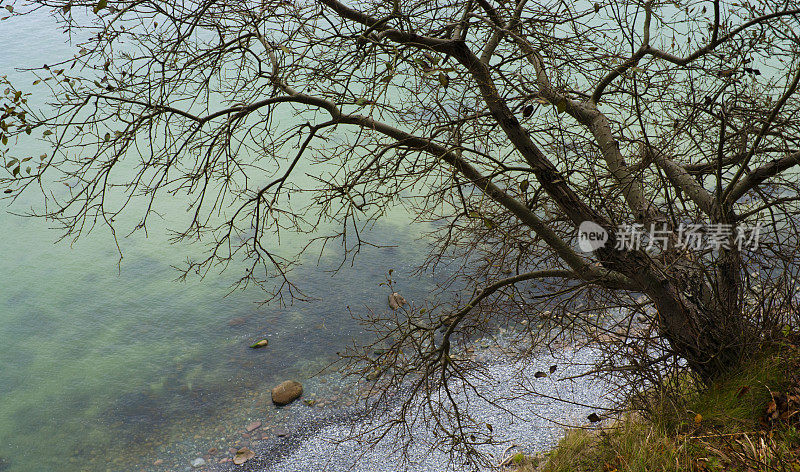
217, 342, 610, 472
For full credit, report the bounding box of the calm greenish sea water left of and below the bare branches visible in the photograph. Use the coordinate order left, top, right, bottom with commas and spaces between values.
0, 11, 438, 472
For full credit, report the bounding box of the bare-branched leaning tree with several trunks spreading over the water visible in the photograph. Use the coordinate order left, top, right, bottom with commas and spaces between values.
2, 0, 800, 464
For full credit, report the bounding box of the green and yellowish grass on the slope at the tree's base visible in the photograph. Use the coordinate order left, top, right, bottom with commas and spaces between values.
514, 347, 800, 472
